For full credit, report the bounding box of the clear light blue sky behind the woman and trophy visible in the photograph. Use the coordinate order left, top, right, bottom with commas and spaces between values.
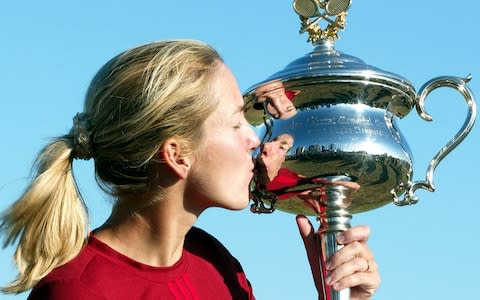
0, 0, 480, 300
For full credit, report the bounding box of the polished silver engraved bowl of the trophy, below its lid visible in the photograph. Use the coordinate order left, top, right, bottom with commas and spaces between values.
247, 102, 412, 215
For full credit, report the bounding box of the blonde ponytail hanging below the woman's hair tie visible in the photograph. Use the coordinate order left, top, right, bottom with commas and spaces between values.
0, 135, 87, 293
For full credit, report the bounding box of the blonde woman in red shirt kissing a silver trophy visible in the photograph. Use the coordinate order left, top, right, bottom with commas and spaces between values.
0, 41, 379, 299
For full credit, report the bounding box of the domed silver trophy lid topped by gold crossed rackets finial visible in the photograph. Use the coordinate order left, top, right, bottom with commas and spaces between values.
245, 0, 416, 118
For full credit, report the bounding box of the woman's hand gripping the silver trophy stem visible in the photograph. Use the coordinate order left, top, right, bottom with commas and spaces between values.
297, 215, 380, 300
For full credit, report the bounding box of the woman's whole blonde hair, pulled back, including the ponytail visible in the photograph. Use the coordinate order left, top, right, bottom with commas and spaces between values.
0, 40, 223, 293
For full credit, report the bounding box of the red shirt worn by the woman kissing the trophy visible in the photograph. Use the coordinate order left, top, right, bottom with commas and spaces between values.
28, 227, 255, 300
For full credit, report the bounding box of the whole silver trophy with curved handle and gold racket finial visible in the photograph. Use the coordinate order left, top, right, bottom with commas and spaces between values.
244, 0, 476, 299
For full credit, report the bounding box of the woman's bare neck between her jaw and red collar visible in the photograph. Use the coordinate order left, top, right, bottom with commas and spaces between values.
95, 193, 198, 267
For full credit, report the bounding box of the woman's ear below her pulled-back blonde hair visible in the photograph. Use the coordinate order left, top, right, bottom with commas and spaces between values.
158, 138, 192, 179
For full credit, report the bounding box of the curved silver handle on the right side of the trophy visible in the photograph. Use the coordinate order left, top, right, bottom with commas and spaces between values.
393, 74, 477, 205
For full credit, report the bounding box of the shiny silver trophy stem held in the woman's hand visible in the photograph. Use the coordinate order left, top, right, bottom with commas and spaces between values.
318, 175, 359, 300
